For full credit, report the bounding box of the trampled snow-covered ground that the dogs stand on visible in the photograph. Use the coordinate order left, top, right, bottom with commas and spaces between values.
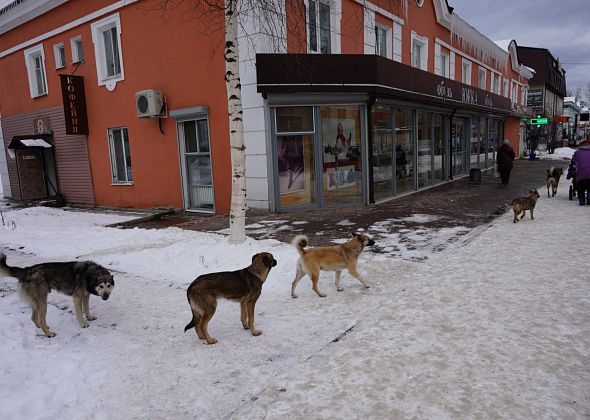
0, 177, 590, 419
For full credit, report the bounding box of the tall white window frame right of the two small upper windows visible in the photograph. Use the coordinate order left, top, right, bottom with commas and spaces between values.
90, 13, 125, 91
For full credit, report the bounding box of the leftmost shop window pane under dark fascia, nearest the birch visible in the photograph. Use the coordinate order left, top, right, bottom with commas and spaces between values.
275, 106, 316, 208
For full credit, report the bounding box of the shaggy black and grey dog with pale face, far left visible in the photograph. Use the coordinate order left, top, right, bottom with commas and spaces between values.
0, 254, 115, 337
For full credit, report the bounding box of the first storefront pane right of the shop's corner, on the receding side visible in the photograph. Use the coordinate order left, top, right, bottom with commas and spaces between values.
372, 106, 394, 200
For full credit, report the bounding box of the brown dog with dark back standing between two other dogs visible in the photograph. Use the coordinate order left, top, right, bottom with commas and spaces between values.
184, 252, 277, 344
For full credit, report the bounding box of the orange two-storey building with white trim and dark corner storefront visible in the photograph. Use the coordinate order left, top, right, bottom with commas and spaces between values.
0, 0, 533, 213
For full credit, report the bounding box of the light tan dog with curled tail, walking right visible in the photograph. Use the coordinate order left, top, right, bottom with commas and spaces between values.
291, 233, 375, 298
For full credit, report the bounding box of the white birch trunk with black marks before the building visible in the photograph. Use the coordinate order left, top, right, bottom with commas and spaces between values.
224, 0, 246, 244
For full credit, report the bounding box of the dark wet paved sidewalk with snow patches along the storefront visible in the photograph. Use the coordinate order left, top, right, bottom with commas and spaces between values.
134, 160, 570, 248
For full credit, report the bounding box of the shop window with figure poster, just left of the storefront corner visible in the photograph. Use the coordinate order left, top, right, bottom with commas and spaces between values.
320, 106, 363, 205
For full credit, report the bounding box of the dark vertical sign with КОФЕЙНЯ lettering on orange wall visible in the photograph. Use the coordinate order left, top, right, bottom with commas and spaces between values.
59, 74, 88, 135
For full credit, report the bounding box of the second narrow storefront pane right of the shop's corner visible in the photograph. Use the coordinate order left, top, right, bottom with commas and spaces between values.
395, 108, 415, 194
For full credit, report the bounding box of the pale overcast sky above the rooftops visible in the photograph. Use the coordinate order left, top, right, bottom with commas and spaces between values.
448, 0, 590, 95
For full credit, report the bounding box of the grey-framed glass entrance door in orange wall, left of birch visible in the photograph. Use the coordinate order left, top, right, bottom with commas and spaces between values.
183, 118, 215, 212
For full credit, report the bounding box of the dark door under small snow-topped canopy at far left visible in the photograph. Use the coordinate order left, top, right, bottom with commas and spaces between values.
16, 149, 47, 200
